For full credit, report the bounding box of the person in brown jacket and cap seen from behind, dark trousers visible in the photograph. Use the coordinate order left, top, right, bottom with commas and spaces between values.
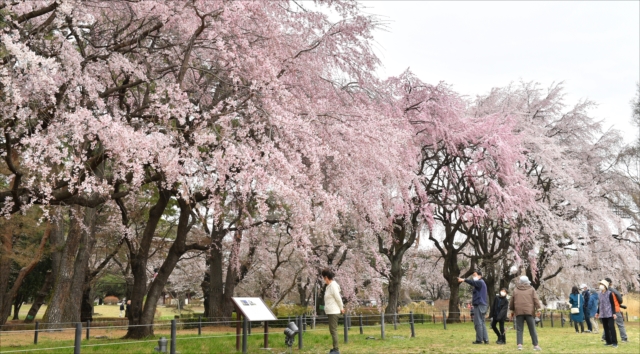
509, 275, 542, 350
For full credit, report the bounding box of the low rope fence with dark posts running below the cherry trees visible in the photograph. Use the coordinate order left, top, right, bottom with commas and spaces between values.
0, 310, 628, 354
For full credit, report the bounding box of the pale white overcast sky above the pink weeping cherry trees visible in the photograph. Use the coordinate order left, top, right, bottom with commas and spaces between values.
362, 0, 640, 141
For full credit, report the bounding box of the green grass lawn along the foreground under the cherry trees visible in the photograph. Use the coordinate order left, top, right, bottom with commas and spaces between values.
0, 322, 640, 354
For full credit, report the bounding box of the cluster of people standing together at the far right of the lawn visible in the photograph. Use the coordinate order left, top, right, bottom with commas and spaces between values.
569, 278, 628, 347
